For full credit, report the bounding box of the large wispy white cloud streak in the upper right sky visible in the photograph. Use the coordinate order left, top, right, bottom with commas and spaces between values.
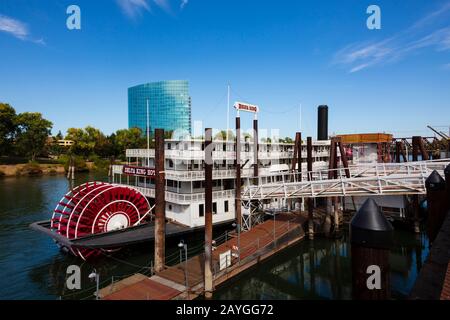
333, 2, 450, 73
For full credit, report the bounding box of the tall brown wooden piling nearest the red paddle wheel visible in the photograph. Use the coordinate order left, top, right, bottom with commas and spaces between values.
155, 129, 166, 272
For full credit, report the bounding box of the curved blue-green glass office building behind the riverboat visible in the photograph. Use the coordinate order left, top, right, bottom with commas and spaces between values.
128, 80, 192, 135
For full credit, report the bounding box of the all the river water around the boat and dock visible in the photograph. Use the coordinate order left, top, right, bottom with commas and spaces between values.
0, 174, 428, 299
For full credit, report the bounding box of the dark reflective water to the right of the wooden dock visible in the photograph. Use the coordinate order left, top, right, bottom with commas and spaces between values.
214, 230, 428, 299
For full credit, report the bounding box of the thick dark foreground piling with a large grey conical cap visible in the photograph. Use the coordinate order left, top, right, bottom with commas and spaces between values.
350, 198, 394, 300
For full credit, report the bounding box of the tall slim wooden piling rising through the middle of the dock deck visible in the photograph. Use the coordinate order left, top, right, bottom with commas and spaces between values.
204, 128, 213, 299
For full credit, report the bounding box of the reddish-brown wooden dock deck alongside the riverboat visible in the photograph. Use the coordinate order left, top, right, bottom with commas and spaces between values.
99, 213, 307, 300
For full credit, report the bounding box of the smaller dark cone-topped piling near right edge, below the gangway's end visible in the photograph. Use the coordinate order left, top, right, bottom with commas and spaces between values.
425, 170, 448, 243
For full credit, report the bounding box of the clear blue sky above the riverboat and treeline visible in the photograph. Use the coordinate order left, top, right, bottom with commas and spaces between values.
0, 0, 450, 137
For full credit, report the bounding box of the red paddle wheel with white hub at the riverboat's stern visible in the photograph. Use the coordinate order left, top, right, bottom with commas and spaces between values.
51, 182, 150, 260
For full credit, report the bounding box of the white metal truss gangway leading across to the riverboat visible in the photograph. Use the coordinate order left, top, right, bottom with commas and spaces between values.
241, 159, 450, 201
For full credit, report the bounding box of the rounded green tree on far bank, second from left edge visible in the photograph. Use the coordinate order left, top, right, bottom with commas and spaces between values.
16, 112, 53, 161
